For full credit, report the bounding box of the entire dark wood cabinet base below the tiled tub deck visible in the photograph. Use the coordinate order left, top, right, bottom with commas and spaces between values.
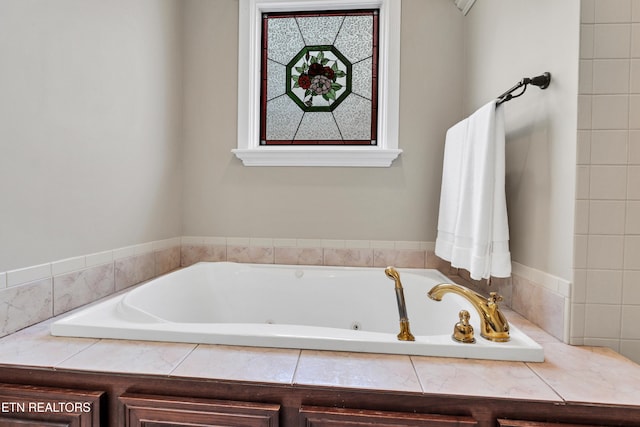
0, 365, 640, 427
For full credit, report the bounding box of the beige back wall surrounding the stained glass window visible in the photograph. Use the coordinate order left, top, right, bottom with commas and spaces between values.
183, 0, 463, 241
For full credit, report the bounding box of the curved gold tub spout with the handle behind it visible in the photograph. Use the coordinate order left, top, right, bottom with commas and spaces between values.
428, 283, 509, 342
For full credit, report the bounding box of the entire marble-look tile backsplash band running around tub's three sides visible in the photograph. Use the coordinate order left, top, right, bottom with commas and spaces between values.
0, 236, 596, 360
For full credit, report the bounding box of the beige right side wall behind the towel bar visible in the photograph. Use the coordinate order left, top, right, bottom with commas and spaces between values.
465, 0, 580, 281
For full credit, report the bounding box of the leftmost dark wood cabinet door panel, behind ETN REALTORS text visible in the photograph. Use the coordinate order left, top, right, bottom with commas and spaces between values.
0, 384, 104, 427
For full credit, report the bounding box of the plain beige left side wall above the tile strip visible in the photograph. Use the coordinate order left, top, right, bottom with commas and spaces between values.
0, 0, 182, 271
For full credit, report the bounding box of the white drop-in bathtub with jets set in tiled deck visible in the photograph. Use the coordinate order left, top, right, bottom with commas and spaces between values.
51, 262, 544, 362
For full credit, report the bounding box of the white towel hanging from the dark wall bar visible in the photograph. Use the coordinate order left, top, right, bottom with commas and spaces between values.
435, 100, 511, 280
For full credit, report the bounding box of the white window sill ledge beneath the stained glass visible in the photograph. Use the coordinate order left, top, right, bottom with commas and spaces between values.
231, 145, 402, 167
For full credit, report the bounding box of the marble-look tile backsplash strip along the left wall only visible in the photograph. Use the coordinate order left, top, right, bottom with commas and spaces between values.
0, 238, 180, 336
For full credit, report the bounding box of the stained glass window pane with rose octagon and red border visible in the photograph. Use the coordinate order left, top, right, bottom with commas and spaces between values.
260, 9, 378, 146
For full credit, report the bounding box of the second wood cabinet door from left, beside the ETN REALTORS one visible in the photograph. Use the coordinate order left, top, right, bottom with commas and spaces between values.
120, 394, 280, 427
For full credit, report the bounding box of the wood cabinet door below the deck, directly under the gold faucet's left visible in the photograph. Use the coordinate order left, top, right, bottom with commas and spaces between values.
300, 406, 478, 427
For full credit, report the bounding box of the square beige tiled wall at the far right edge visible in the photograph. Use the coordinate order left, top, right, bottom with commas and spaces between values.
570, 0, 640, 361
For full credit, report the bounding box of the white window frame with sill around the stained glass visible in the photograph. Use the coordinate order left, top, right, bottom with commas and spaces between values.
231, 0, 402, 167
